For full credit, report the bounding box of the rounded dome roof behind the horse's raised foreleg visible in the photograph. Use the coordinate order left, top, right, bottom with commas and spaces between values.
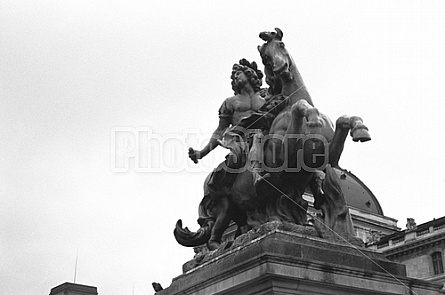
334, 168, 383, 215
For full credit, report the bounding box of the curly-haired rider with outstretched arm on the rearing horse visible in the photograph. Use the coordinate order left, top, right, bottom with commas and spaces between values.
189, 59, 265, 195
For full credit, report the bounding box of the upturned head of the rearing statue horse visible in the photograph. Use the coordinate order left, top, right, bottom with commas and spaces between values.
258, 28, 293, 87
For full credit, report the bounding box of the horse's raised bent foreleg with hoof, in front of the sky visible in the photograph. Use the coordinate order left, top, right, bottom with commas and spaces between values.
329, 116, 371, 167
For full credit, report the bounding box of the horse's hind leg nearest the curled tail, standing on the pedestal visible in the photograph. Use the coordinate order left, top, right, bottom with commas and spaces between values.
207, 197, 231, 251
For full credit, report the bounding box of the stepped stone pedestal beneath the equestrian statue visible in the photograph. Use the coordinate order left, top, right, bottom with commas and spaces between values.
156, 228, 441, 295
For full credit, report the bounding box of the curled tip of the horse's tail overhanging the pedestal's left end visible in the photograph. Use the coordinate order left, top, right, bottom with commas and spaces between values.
173, 219, 213, 247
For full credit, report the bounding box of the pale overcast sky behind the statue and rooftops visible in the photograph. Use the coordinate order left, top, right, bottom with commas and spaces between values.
0, 0, 445, 295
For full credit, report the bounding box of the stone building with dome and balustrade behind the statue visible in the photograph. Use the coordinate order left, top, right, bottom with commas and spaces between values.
318, 169, 445, 290
